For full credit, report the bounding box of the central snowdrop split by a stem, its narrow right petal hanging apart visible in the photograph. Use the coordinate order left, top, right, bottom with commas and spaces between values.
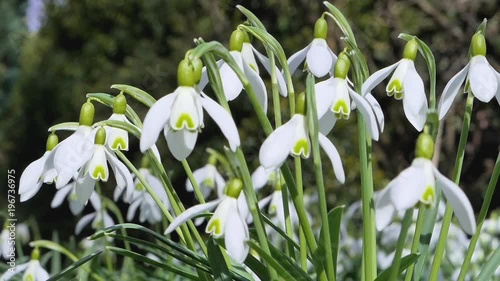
259, 93, 345, 183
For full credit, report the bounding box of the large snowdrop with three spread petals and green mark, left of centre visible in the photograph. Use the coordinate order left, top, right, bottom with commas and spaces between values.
140, 55, 240, 161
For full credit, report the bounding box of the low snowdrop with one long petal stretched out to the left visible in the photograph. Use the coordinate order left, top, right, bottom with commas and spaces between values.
165, 179, 250, 264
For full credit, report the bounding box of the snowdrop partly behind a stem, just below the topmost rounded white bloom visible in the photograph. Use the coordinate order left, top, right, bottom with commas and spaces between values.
314, 52, 383, 140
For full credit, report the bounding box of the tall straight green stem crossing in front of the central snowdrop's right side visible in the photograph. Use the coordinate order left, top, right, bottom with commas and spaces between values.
304, 73, 336, 280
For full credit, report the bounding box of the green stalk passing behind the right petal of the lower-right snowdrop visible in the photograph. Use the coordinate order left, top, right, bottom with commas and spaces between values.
429, 92, 474, 280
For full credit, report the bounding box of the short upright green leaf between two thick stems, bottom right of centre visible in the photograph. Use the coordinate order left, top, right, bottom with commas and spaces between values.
313, 206, 345, 275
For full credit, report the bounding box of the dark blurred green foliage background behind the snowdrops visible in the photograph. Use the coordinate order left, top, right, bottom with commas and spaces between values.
0, 0, 500, 236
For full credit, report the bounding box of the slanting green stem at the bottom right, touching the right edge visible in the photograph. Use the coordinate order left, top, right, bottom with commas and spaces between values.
457, 153, 500, 281
